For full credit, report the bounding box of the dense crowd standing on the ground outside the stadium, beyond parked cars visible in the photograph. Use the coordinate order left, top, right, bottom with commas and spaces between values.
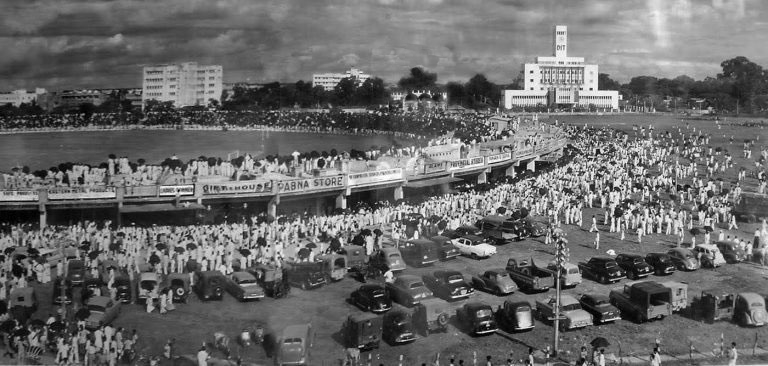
0, 118, 768, 364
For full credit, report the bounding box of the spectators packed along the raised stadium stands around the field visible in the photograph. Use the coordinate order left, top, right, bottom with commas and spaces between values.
2, 112, 560, 189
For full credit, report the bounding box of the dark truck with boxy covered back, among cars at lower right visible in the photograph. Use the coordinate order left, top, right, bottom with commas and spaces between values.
609, 281, 672, 323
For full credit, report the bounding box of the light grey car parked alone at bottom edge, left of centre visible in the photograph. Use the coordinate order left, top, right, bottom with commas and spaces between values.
275, 324, 315, 366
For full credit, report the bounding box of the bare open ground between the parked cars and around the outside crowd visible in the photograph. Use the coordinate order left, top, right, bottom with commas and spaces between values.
22, 116, 768, 365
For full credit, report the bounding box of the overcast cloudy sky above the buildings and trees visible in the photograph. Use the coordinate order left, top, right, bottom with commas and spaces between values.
0, 0, 768, 90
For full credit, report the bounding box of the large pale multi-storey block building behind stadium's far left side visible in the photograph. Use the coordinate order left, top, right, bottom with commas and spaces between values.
141, 62, 224, 107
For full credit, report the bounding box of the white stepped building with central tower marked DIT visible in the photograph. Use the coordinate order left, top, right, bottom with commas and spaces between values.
504, 25, 620, 110
